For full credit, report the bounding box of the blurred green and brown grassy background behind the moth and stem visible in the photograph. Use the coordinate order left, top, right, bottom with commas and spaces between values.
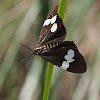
0, 0, 100, 100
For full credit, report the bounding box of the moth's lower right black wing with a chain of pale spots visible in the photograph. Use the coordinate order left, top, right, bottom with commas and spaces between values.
39, 41, 86, 73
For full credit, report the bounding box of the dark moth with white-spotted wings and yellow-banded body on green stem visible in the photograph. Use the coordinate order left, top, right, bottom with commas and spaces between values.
21, 6, 87, 73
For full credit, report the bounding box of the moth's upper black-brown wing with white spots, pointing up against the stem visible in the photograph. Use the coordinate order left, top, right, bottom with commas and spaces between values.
38, 6, 66, 47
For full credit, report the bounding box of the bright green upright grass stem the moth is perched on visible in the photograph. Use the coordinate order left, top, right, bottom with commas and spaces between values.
43, 0, 67, 100
